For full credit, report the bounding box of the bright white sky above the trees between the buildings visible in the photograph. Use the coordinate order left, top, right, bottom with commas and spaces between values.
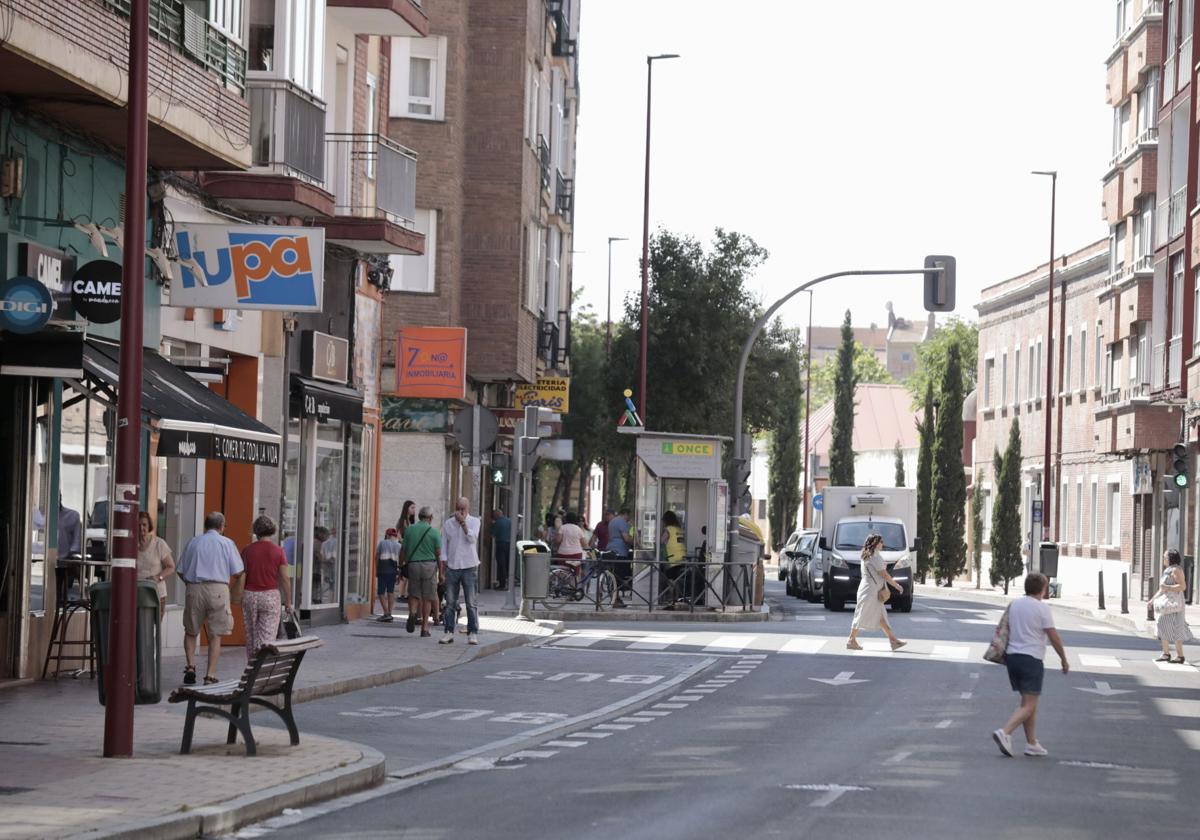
575, 0, 1115, 333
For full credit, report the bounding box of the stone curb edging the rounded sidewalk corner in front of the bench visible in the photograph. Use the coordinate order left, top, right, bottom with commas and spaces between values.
76, 744, 386, 840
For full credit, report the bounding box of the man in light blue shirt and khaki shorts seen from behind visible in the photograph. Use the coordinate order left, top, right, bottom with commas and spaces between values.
176, 511, 246, 685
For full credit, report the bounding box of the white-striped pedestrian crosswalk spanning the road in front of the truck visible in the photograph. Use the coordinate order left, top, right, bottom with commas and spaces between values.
545, 629, 1196, 674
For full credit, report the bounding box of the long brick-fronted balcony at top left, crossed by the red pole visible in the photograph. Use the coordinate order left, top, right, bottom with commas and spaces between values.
0, 0, 250, 169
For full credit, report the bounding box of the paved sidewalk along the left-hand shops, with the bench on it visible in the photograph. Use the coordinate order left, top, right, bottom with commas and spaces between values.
0, 600, 560, 840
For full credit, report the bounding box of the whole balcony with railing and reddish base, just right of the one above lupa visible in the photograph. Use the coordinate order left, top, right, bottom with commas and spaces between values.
323, 134, 425, 254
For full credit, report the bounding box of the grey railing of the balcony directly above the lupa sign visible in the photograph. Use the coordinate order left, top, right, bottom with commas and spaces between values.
246, 79, 325, 185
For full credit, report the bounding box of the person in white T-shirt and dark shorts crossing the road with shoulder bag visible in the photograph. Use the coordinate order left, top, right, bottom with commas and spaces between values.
991, 572, 1070, 757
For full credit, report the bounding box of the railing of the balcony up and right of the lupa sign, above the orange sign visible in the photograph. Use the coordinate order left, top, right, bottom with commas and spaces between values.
325, 134, 416, 227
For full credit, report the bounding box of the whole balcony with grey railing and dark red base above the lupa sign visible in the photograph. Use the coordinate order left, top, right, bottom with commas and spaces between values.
203, 78, 334, 216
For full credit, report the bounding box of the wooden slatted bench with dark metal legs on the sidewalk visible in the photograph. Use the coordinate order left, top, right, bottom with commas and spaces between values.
167, 636, 323, 756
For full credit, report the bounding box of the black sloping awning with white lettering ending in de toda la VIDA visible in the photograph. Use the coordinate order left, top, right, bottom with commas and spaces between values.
83, 340, 280, 467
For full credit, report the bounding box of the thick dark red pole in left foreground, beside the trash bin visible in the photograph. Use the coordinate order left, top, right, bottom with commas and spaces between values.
104, 0, 150, 758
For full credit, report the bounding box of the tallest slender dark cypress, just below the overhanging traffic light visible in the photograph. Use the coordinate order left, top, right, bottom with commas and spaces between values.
932, 344, 967, 586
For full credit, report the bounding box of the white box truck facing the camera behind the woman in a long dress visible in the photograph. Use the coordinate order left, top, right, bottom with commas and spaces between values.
817, 487, 919, 612
